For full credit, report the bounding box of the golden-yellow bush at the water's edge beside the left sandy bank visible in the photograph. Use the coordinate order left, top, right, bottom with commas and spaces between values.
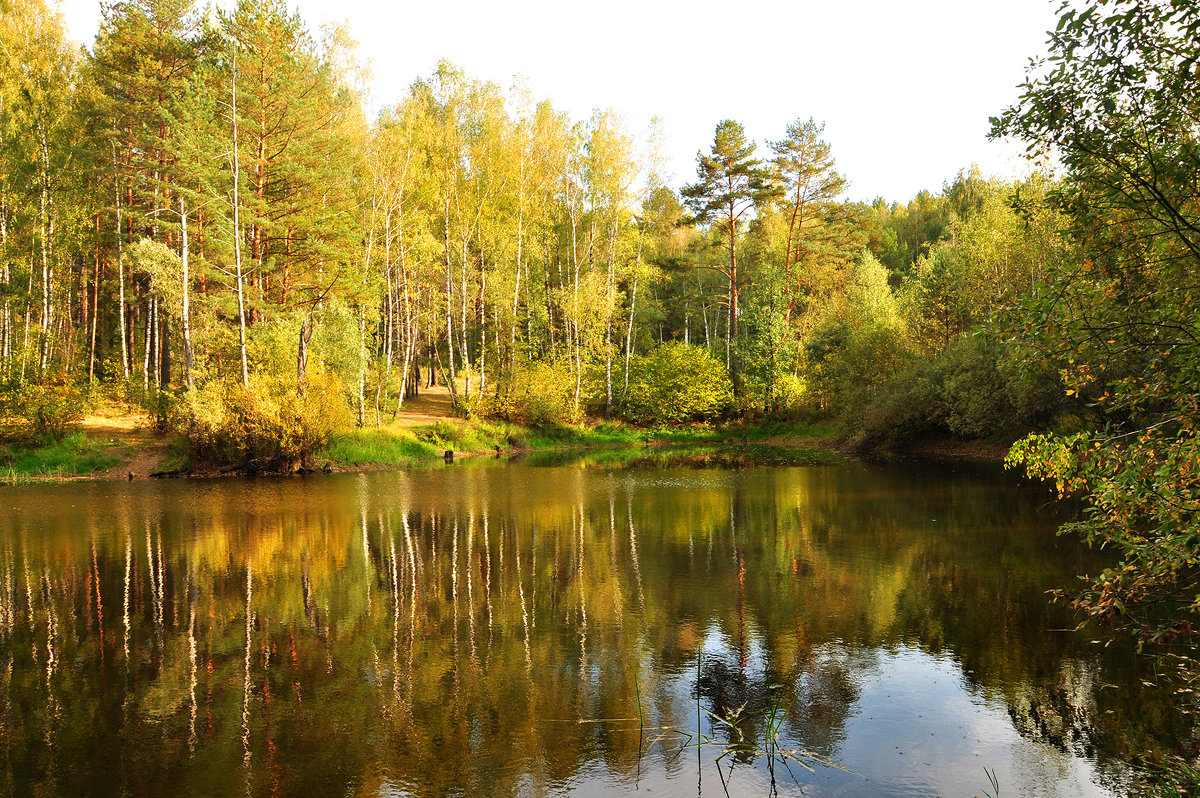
180, 372, 352, 470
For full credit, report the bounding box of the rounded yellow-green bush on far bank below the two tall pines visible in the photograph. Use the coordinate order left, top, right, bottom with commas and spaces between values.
619, 341, 733, 425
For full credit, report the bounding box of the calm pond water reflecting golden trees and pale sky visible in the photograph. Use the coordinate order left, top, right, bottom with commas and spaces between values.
0, 464, 1196, 796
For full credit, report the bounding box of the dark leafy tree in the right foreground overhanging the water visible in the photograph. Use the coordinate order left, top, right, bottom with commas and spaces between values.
994, 0, 1200, 641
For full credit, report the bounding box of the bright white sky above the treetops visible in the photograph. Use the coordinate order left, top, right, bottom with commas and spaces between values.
60, 0, 1058, 202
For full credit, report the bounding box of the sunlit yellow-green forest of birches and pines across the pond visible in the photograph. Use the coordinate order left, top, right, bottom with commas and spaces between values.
0, 0, 1063, 451
